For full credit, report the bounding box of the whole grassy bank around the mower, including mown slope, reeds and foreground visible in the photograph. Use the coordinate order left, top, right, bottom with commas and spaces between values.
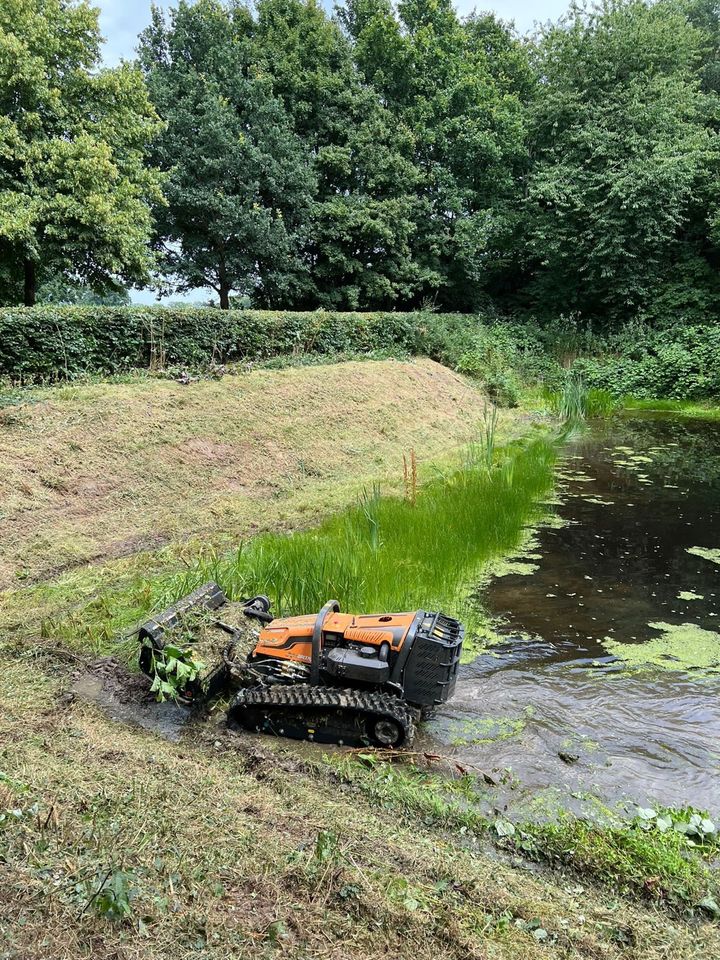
0, 361, 720, 960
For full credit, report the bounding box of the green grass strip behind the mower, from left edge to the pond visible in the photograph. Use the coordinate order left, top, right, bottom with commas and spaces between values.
9, 430, 557, 662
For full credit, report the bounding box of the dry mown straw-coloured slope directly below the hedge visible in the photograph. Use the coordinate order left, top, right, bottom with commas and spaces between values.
0, 360, 483, 590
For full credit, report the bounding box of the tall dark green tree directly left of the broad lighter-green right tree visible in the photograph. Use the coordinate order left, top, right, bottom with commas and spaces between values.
341, 0, 532, 310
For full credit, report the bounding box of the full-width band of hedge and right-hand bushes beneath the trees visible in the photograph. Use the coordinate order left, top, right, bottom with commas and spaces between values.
0, 305, 720, 406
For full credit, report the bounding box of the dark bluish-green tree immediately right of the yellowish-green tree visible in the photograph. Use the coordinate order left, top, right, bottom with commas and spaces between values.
139, 0, 314, 309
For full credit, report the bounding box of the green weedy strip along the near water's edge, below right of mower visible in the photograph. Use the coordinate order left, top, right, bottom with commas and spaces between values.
324, 753, 720, 914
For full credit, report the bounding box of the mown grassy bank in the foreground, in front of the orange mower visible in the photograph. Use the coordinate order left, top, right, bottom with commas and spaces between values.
0, 650, 720, 960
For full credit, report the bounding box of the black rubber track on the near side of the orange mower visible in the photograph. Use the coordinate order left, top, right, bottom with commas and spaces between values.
228, 683, 418, 747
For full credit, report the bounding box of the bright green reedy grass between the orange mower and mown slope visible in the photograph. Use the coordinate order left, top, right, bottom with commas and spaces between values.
158, 436, 556, 632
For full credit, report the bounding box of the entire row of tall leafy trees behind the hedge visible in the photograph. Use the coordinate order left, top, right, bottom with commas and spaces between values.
0, 0, 720, 324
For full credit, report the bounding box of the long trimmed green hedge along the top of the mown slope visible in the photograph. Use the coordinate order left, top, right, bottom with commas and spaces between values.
0, 305, 560, 386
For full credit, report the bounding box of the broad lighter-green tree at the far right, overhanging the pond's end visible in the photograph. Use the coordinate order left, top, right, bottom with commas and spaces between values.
528, 0, 718, 322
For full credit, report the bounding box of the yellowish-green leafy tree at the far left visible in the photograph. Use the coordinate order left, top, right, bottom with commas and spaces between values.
0, 0, 160, 305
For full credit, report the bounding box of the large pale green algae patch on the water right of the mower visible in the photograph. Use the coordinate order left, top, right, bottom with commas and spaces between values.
603, 621, 720, 670
